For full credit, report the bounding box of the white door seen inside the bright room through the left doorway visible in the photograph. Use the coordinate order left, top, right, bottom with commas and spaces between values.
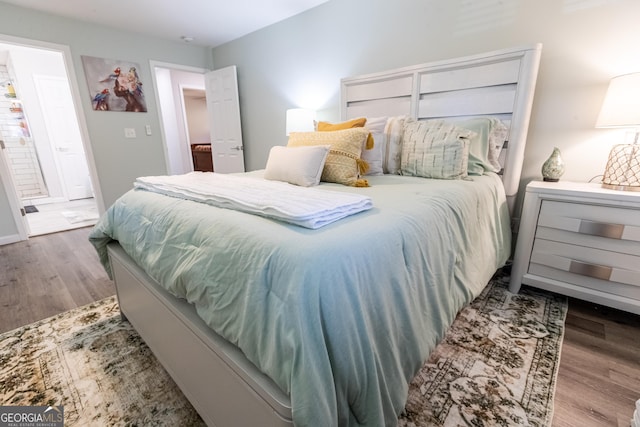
33, 75, 93, 200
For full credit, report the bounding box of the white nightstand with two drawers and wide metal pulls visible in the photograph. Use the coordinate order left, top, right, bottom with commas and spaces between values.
509, 181, 640, 314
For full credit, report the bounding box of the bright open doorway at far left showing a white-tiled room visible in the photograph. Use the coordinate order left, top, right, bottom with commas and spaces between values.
0, 35, 100, 239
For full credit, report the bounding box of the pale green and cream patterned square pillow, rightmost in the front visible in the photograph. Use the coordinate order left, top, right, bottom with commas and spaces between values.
400, 120, 475, 179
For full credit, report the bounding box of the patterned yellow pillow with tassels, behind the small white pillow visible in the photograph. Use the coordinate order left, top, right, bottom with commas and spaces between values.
287, 128, 369, 187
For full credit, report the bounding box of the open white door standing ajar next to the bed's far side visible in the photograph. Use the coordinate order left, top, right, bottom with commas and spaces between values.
205, 65, 244, 173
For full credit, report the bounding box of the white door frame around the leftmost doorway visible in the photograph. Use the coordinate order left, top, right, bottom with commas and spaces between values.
0, 33, 105, 243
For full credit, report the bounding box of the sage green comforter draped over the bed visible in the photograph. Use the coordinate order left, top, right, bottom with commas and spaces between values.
90, 172, 511, 427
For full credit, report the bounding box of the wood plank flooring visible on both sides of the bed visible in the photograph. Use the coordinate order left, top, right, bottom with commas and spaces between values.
0, 228, 640, 427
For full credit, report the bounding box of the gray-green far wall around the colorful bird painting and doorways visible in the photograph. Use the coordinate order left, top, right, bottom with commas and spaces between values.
0, 3, 212, 241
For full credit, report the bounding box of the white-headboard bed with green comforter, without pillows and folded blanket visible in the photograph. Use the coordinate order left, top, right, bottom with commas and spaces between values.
90, 45, 541, 426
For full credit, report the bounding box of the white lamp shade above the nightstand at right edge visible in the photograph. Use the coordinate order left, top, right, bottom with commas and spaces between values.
596, 73, 640, 128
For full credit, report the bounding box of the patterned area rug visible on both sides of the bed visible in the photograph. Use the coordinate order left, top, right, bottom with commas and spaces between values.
0, 276, 567, 427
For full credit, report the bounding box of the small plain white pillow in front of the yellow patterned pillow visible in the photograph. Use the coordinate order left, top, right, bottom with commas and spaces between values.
264, 145, 330, 187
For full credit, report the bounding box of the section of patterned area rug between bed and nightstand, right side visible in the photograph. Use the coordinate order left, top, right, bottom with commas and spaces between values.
398, 273, 567, 427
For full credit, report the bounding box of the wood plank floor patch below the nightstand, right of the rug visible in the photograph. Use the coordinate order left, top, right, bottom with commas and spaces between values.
553, 299, 640, 427
